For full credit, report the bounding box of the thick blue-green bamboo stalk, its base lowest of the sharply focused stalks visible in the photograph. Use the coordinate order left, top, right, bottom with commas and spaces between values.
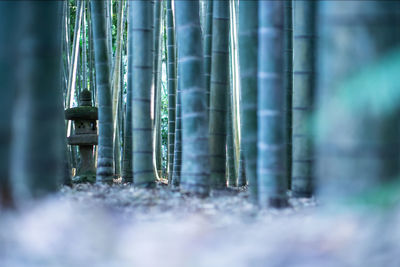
257, 1, 287, 207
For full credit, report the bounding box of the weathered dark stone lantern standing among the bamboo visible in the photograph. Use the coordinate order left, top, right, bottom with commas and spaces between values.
65, 90, 98, 183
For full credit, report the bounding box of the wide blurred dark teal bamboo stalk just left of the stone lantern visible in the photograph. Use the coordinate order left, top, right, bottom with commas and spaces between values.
7, 1, 65, 200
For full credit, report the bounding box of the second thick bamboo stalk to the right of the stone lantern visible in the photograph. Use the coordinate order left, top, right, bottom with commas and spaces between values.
128, 1, 155, 187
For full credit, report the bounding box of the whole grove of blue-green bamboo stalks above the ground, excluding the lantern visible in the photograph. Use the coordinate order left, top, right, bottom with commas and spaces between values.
0, 0, 400, 207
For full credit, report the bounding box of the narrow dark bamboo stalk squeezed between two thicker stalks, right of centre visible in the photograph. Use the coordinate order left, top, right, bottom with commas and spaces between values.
283, 0, 294, 189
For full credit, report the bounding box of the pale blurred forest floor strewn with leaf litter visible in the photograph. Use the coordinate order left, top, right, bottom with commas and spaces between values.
0, 185, 400, 267
